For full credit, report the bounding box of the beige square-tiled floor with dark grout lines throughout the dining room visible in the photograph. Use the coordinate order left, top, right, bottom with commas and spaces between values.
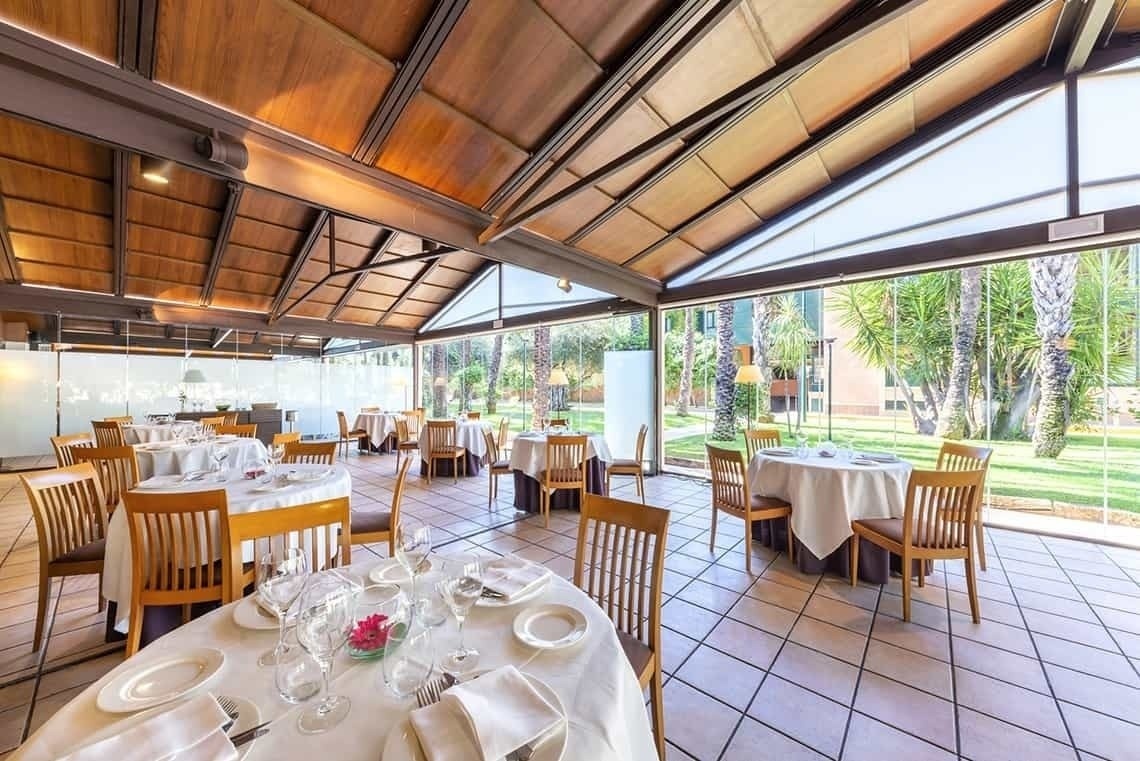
0, 456, 1140, 761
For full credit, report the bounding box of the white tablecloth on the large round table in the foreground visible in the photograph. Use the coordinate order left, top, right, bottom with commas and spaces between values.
13, 562, 661, 761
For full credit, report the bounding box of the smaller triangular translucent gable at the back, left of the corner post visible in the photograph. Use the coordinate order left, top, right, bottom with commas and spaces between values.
421, 264, 613, 332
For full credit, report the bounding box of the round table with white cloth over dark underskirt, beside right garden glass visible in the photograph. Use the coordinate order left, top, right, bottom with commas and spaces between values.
748, 448, 912, 584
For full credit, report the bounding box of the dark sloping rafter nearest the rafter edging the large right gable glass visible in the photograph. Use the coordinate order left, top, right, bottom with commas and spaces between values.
622, 0, 1056, 267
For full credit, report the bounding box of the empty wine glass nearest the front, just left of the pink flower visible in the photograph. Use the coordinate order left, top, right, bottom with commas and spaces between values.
296, 575, 356, 735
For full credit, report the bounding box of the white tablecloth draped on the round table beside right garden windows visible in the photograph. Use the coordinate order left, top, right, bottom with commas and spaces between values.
748, 452, 911, 558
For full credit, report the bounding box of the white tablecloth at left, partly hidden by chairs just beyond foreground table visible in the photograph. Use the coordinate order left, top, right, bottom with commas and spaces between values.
103, 465, 352, 632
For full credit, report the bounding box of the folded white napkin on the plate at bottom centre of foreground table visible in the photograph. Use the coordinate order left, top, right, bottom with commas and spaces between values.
408, 665, 562, 761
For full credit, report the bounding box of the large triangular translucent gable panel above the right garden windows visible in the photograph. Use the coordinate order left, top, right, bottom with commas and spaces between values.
669, 87, 1066, 285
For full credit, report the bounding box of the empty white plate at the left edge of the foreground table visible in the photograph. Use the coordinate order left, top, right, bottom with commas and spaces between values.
95, 647, 226, 713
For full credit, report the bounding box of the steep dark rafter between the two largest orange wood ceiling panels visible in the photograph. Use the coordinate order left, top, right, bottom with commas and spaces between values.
352, 0, 467, 165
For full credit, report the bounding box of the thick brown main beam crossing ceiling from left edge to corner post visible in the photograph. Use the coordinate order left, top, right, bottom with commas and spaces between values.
0, 23, 661, 304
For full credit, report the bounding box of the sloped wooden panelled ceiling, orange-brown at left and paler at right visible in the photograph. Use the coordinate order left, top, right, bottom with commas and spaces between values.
0, 0, 1140, 329
